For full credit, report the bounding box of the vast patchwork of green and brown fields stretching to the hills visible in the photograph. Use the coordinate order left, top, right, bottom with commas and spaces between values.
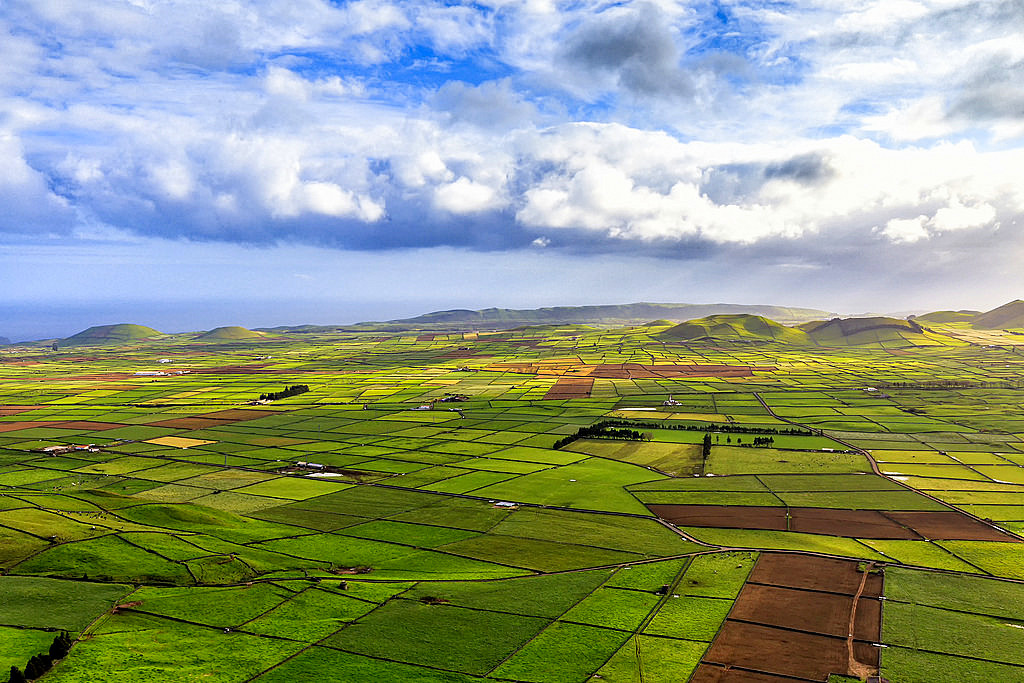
6, 318, 1024, 683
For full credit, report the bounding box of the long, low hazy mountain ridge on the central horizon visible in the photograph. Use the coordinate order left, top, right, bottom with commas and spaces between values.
372, 303, 834, 329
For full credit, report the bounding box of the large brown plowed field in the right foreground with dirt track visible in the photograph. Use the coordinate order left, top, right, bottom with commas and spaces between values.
691, 553, 882, 683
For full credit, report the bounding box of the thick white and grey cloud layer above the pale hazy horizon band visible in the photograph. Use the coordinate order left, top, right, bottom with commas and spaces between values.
0, 0, 1024, 261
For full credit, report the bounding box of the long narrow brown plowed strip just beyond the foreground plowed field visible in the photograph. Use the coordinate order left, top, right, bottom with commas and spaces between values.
647, 505, 1018, 542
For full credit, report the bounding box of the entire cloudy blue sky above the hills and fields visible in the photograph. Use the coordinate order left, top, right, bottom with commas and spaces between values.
0, 0, 1024, 339
